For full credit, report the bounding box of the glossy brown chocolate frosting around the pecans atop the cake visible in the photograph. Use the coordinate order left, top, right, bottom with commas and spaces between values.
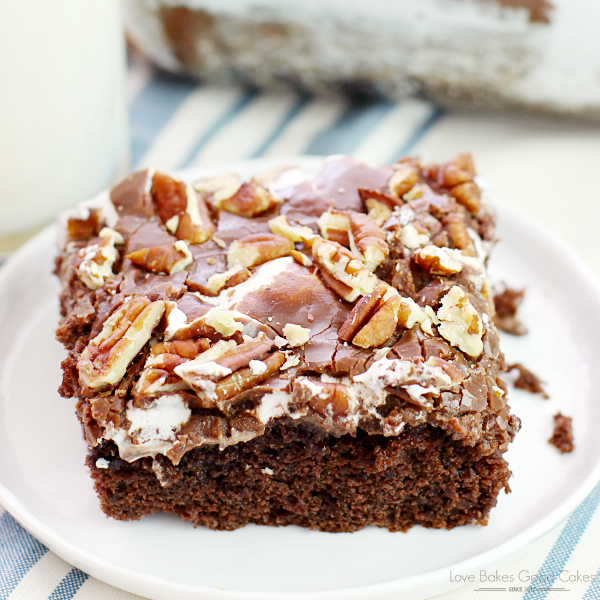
57, 157, 519, 461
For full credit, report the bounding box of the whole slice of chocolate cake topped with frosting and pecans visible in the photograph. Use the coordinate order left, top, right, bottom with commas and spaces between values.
56, 154, 520, 531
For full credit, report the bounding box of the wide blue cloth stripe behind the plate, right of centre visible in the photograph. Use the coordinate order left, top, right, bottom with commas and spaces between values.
306, 101, 395, 156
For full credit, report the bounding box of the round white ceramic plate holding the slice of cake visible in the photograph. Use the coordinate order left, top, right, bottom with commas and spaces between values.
0, 158, 600, 600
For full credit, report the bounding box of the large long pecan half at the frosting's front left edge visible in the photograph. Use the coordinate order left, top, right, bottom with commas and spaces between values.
77, 296, 165, 389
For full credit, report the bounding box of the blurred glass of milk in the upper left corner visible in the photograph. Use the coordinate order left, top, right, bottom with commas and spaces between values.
0, 0, 129, 253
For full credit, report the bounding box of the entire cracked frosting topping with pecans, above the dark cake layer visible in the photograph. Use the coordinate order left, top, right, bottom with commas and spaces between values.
57, 154, 519, 464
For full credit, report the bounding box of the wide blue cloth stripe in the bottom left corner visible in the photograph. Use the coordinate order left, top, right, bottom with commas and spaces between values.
0, 513, 48, 600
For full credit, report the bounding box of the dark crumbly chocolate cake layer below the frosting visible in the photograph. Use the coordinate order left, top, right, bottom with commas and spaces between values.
88, 420, 510, 531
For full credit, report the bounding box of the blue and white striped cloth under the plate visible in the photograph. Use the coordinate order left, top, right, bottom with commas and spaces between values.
0, 55, 600, 600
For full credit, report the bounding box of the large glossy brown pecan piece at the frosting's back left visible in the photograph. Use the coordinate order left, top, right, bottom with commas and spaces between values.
152, 172, 215, 244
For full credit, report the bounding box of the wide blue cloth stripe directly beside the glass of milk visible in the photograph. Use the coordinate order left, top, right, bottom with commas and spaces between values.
129, 72, 198, 165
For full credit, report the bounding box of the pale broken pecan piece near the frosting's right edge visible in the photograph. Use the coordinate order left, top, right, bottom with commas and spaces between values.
437, 285, 483, 358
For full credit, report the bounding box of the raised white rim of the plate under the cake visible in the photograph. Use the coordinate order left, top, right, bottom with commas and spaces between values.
0, 155, 600, 600
